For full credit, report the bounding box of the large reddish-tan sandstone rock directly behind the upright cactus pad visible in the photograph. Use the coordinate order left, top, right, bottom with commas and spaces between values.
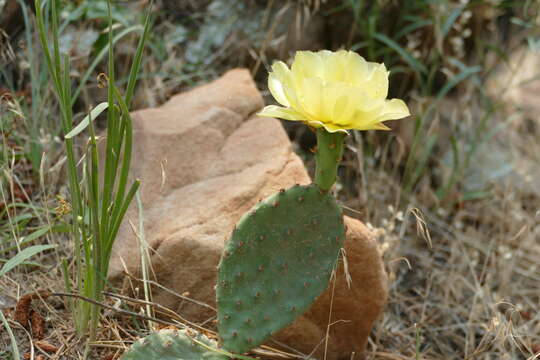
110, 70, 387, 359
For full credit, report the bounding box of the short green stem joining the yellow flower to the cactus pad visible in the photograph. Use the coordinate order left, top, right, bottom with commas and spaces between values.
314, 128, 347, 191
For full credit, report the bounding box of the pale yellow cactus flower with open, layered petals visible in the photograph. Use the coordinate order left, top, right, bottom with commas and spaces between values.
258, 50, 410, 132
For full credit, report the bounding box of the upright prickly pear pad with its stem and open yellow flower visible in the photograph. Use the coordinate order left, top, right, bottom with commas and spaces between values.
216, 50, 409, 353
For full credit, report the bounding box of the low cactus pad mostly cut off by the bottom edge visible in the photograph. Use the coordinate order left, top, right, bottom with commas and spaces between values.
120, 329, 228, 360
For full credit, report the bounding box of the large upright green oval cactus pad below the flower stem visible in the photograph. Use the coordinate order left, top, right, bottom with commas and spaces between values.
216, 184, 345, 353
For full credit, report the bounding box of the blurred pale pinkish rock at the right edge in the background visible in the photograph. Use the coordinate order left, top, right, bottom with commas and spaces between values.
480, 46, 540, 197
